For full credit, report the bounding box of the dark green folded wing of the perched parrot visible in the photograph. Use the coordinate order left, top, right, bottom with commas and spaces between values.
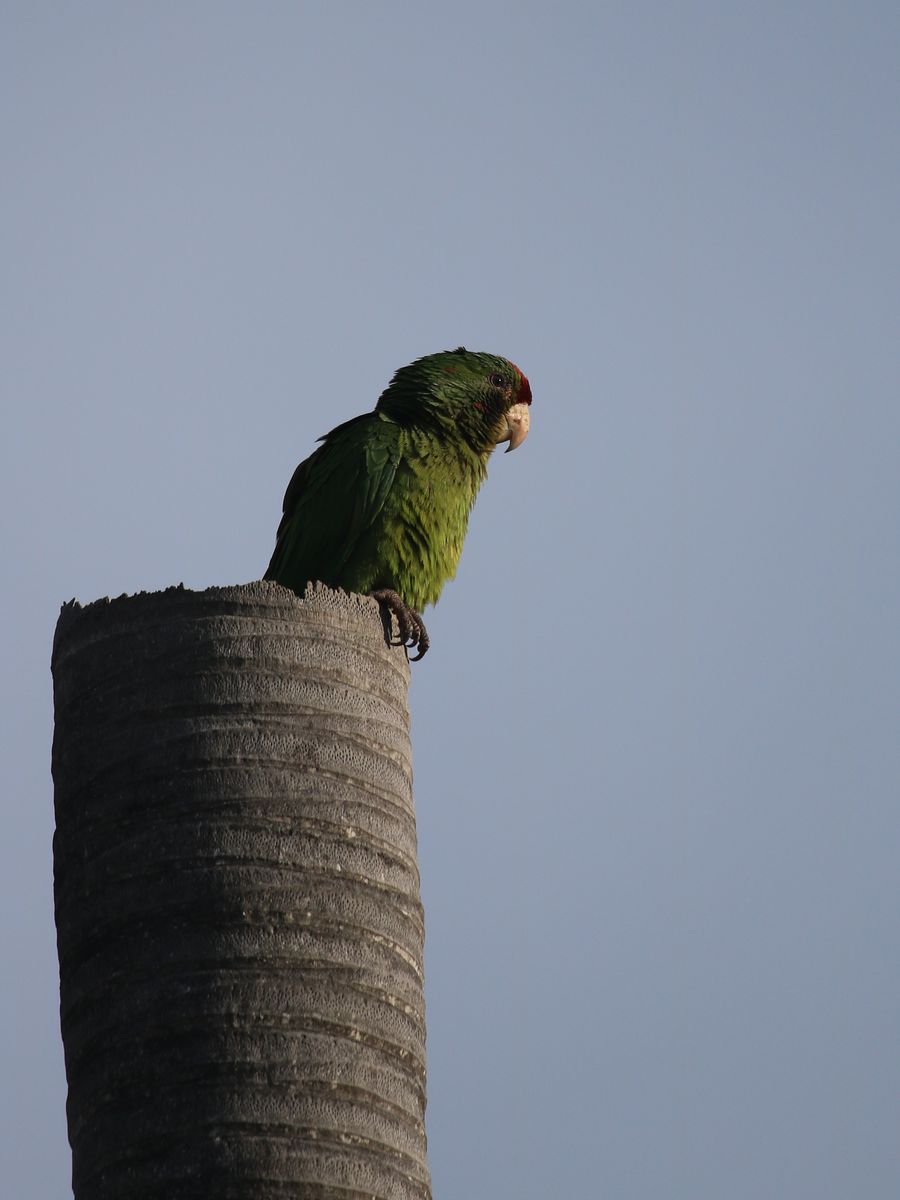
265, 413, 401, 595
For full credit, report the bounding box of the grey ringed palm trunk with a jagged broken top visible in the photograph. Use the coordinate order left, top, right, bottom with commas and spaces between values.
53, 583, 430, 1200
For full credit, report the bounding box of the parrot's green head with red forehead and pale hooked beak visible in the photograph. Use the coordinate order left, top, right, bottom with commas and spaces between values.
377, 346, 532, 455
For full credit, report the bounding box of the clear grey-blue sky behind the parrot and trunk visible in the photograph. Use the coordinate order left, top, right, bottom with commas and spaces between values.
0, 0, 900, 1200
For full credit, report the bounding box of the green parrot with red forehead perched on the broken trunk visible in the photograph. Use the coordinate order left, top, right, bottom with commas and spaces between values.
265, 346, 532, 661
